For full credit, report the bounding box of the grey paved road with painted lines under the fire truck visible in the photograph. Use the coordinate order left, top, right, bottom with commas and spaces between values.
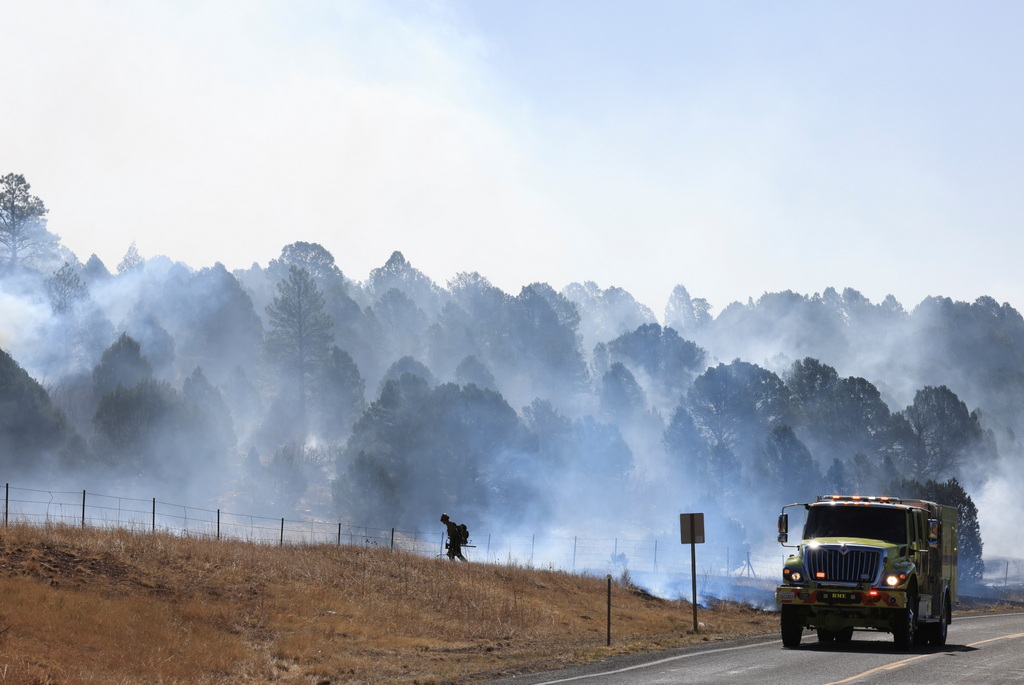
489, 612, 1024, 685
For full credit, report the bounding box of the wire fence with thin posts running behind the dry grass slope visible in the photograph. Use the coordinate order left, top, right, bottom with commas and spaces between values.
2, 483, 1024, 604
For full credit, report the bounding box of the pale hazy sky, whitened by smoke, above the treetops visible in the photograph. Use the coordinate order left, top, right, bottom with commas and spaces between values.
0, 0, 1024, 315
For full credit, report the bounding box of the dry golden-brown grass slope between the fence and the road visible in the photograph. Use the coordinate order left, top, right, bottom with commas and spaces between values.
0, 525, 777, 684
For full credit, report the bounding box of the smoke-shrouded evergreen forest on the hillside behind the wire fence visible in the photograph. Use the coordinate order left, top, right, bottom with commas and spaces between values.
0, 174, 1024, 577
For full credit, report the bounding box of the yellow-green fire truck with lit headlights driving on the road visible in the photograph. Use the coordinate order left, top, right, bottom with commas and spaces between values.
775, 495, 957, 651
